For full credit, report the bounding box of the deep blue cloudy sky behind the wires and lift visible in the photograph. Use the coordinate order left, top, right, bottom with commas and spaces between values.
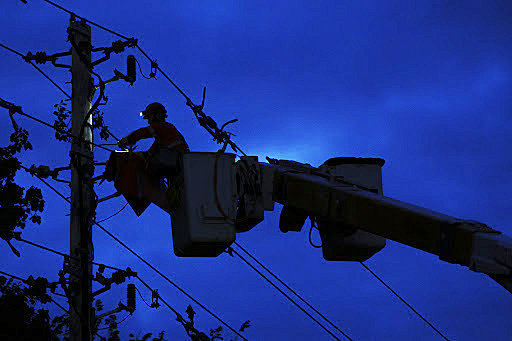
0, 0, 512, 340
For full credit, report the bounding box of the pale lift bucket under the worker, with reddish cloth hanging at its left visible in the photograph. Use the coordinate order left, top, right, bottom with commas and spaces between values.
105, 151, 237, 257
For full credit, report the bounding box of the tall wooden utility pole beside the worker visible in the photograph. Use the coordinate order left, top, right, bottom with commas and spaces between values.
68, 15, 95, 341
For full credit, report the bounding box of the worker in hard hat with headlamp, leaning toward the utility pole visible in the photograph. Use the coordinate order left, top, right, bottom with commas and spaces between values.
118, 102, 190, 212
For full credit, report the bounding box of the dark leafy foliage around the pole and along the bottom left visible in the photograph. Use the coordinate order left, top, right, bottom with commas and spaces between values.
0, 101, 250, 341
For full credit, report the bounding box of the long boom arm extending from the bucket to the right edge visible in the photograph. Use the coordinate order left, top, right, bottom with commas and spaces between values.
237, 157, 512, 293
